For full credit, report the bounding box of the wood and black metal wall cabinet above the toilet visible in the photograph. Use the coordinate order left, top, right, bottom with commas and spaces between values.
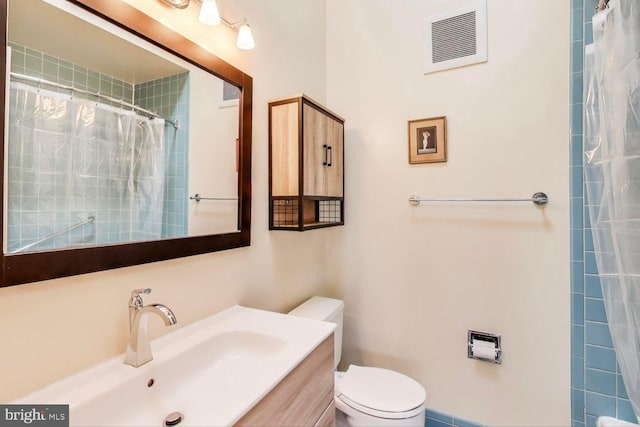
269, 95, 344, 231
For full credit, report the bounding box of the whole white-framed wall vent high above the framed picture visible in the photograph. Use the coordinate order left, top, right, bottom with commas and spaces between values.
422, 0, 487, 74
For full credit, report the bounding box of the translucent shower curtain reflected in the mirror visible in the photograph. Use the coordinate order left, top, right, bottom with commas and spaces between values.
7, 82, 165, 253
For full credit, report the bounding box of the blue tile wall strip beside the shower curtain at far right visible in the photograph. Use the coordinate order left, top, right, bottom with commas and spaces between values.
569, 0, 636, 427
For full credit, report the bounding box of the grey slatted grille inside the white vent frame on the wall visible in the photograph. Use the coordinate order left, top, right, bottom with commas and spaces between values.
431, 11, 477, 63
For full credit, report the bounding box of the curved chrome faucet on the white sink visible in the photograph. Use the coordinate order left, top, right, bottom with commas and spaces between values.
124, 288, 177, 368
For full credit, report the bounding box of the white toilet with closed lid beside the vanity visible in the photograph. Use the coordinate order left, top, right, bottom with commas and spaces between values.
289, 297, 426, 427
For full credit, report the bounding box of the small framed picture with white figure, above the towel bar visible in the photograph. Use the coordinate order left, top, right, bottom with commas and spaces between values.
409, 116, 447, 164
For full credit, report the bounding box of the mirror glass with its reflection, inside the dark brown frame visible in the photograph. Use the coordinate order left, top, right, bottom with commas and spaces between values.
4, 0, 240, 254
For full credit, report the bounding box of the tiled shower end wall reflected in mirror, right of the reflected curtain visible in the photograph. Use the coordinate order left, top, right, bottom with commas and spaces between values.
134, 73, 189, 237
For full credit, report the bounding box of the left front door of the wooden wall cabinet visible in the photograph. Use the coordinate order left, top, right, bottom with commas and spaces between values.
302, 104, 328, 196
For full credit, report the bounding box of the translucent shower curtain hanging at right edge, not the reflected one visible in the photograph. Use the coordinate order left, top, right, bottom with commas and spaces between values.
584, 0, 640, 415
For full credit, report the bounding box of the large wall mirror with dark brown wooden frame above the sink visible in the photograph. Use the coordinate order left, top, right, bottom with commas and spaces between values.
0, 0, 252, 286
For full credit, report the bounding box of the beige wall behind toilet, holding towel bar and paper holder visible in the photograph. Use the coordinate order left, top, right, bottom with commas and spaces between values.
326, 0, 570, 426
